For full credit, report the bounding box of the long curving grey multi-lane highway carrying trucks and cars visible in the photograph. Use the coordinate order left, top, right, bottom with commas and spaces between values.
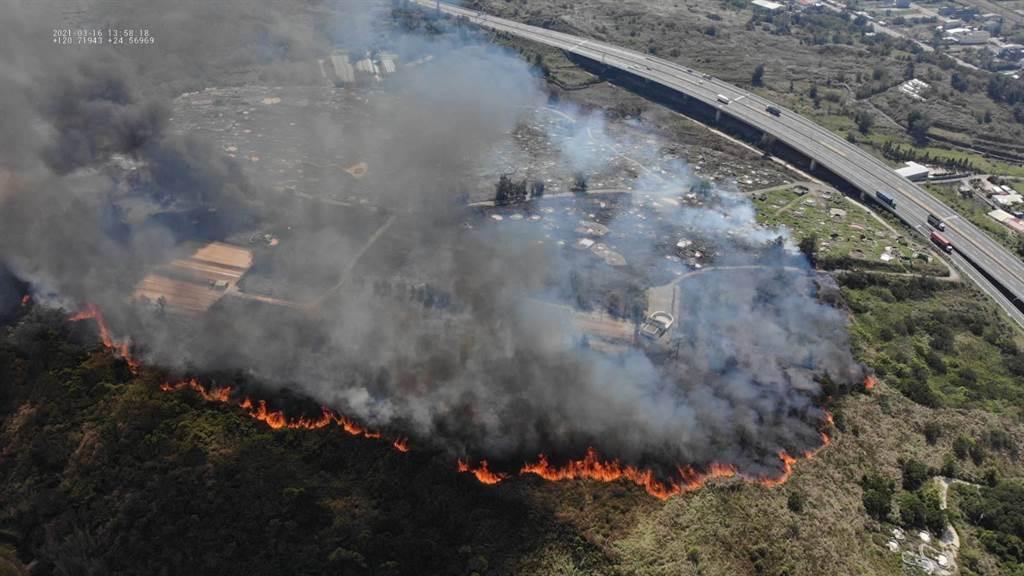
414, 0, 1024, 327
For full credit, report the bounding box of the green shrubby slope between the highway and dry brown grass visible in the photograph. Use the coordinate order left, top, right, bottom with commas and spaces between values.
841, 274, 1024, 413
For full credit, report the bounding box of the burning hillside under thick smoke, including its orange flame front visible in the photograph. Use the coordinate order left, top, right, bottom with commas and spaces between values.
0, 2, 863, 497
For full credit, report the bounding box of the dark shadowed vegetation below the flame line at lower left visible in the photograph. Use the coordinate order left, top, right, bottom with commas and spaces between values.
0, 308, 606, 575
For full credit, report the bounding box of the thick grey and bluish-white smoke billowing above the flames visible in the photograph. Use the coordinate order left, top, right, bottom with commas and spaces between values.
0, 2, 860, 475
